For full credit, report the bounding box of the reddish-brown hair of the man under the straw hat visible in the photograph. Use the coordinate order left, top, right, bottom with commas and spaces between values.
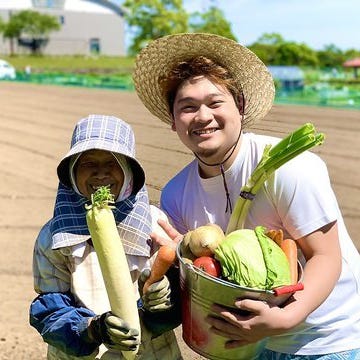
159, 56, 243, 114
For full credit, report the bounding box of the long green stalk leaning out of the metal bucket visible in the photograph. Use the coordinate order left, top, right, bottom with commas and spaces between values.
226, 123, 325, 234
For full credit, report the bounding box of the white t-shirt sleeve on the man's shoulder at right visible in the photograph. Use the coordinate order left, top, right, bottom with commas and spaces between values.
267, 152, 339, 239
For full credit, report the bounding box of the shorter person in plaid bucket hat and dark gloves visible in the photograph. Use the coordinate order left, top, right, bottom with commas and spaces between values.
30, 115, 181, 360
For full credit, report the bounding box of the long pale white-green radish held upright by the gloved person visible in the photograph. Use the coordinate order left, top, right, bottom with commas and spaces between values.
86, 186, 141, 360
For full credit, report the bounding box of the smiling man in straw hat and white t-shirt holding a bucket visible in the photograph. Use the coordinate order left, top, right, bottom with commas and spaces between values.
133, 33, 360, 360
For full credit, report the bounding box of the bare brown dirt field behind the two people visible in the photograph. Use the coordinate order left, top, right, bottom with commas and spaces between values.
0, 82, 360, 360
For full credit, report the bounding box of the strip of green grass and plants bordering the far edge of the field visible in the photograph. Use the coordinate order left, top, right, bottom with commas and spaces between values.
0, 55, 360, 109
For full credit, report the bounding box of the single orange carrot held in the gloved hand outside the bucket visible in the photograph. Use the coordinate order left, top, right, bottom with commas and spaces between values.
143, 245, 176, 294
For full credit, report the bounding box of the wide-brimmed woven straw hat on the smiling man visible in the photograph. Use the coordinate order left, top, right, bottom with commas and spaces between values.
133, 33, 275, 124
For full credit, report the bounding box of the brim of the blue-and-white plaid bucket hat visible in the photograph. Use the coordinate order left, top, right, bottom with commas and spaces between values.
57, 140, 145, 194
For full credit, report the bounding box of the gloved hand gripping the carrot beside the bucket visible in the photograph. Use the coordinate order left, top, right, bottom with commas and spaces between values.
138, 269, 172, 312
